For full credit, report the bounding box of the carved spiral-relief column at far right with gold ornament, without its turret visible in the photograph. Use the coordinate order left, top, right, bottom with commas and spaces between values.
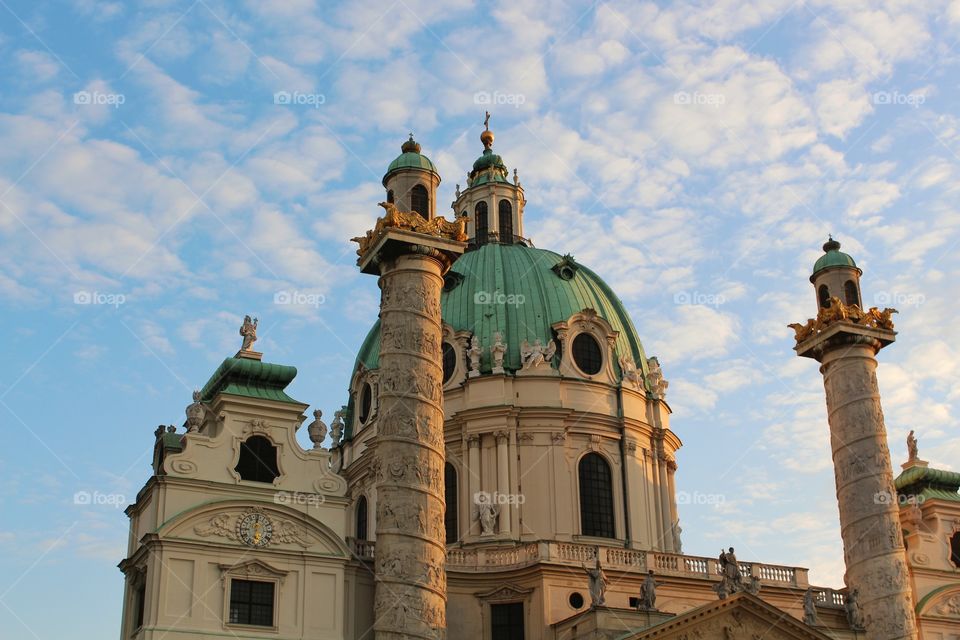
790, 298, 917, 640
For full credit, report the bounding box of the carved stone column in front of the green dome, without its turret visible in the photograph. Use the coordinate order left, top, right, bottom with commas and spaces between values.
358, 221, 464, 640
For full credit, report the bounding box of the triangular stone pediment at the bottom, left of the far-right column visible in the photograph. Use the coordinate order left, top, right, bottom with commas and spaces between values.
624, 593, 829, 640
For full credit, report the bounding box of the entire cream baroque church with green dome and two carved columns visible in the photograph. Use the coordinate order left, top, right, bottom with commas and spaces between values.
120, 128, 960, 640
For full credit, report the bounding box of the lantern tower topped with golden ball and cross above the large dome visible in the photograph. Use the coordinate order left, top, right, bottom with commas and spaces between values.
452, 112, 526, 247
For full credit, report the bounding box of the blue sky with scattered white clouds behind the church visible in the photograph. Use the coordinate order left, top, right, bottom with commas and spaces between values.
0, 0, 960, 640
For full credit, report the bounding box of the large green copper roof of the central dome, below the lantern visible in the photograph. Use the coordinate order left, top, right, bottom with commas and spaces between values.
354, 244, 646, 392
